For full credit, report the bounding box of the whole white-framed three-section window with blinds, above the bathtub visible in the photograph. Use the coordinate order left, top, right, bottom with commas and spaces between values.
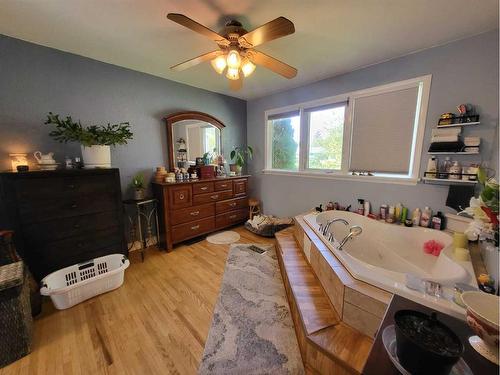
264, 75, 431, 183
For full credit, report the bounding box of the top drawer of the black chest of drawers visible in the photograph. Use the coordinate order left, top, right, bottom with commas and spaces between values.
15, 174, 117, 202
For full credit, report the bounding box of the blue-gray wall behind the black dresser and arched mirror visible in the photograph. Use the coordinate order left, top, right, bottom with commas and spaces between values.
0, 35, 246, 197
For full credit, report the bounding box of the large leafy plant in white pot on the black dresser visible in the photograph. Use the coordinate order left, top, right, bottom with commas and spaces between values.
45, 112, 133, 168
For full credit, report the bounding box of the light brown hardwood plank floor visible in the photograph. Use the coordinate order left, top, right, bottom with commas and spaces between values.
0, 227, 274, 375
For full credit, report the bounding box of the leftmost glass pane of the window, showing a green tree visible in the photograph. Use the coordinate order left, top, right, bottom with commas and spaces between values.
267, 111, 300, 170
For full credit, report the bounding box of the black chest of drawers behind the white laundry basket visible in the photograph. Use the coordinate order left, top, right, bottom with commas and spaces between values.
0, 169, 127, 280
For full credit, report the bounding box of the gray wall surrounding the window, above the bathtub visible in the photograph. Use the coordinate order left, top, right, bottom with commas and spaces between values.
247, 30, 498, 216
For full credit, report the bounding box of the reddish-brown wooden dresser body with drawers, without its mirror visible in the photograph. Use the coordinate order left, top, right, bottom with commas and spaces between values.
153, 176, 249, 250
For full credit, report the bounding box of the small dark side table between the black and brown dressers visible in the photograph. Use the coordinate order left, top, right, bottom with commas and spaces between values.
123, 198, 160, 262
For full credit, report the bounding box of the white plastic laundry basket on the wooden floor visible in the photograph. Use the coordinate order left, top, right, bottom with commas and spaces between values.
40, 254, 130, 310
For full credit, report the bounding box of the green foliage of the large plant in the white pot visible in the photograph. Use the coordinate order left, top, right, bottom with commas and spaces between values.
44, 112, 133, 147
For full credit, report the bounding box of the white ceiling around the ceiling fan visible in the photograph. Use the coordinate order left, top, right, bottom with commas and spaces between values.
0, 0, 498, 99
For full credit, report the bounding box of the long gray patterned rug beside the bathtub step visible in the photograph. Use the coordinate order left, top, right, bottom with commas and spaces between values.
199, 244, 304, 374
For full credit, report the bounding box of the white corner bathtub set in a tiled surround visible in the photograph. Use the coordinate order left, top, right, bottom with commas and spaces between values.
304, 211, 476, 319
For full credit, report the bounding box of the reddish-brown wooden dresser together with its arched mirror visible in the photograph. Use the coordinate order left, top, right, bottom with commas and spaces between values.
153, 112, 249, 250
